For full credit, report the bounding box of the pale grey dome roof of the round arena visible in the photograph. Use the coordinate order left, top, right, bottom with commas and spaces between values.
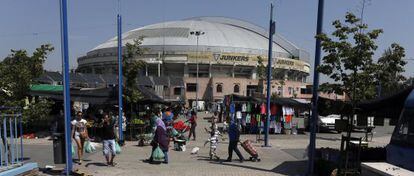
91, 17, 310, 59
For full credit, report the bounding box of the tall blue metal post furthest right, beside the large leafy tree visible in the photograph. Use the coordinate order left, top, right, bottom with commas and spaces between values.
307, 0, 324, 175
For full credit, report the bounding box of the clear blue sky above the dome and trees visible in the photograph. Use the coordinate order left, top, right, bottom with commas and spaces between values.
0, 0, 414, 81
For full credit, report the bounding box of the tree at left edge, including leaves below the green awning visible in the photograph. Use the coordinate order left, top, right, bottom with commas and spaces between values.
0, 44, 54, 124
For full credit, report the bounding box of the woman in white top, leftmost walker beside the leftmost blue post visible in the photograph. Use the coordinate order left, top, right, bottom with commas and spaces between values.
71, 111, 89, 165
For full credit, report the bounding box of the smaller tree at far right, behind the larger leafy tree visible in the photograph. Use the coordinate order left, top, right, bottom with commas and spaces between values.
376, 43, 407, 96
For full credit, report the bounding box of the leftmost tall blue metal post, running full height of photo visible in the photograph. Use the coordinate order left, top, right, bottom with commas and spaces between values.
60, 0, 72, 175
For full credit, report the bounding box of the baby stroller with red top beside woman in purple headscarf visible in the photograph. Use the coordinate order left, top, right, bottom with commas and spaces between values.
171, 121, 190, 151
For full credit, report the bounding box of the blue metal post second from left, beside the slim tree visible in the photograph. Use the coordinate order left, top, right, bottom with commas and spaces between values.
117, 14, 124, 142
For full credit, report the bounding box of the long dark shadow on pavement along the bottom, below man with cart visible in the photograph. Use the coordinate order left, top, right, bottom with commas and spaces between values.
211, 160, 307, 176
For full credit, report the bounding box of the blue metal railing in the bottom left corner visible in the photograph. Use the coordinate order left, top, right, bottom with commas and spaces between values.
0, 107, 23, 173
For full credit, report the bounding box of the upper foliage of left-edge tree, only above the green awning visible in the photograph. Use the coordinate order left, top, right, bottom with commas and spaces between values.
0, 44, 54, 106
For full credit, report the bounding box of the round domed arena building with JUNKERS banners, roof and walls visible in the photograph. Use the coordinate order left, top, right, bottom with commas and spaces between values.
77, 17, 310, 102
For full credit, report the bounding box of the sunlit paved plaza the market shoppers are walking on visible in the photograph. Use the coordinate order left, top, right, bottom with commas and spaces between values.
25, 114, 393, 176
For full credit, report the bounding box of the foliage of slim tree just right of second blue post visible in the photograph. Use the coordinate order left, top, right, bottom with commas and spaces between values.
123, 37, 146, 103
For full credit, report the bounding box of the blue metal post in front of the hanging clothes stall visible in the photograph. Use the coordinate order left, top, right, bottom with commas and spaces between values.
264, 3, 276, 147
